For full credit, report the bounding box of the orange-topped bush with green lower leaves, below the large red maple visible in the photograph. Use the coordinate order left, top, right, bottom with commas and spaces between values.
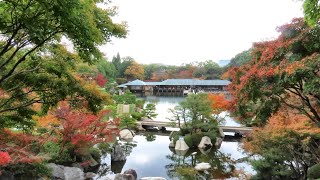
244, 108, 320, 179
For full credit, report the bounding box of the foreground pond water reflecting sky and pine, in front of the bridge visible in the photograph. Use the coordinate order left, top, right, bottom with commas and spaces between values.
96, 133, 253, 179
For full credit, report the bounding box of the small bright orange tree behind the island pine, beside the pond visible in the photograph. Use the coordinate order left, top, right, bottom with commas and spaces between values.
208, 93, 231, 114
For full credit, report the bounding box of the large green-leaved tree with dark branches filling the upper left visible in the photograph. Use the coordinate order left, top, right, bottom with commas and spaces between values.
0, 0, 126, 127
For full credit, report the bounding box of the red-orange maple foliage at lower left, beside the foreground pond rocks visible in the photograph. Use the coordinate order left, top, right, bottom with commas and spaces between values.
0, 102, 119, 173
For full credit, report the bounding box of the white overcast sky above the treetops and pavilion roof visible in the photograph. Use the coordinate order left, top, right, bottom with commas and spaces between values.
101, 0, 303, 65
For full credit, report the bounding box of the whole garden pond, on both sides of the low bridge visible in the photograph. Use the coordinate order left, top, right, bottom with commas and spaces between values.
97, 96, 254, 179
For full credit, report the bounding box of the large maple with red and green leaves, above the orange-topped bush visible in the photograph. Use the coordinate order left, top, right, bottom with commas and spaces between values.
225, 18, 320, 125
